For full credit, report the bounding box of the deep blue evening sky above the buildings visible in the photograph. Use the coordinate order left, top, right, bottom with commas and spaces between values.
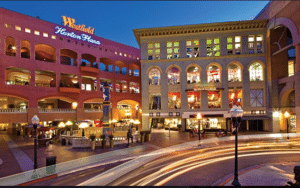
0, 1, 268, 48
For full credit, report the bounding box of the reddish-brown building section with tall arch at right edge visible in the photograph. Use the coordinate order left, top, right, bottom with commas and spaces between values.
255, 1, 300, 132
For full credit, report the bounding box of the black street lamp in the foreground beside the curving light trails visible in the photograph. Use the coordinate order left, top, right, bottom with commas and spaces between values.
230, 105, 244, 187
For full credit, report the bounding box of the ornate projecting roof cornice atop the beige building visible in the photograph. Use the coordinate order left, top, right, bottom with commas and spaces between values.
133, 20, 268, 45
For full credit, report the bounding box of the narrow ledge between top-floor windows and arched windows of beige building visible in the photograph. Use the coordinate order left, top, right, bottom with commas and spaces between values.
141, 53, 266, 63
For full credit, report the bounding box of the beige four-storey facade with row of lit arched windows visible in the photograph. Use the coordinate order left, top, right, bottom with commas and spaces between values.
134, 19, 273, 131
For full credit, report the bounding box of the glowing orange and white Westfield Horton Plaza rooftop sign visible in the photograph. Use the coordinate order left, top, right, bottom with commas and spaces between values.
55, 16, 101, 45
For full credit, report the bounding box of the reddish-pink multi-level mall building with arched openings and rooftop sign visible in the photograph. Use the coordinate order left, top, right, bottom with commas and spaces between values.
0, 8, 141, 134
